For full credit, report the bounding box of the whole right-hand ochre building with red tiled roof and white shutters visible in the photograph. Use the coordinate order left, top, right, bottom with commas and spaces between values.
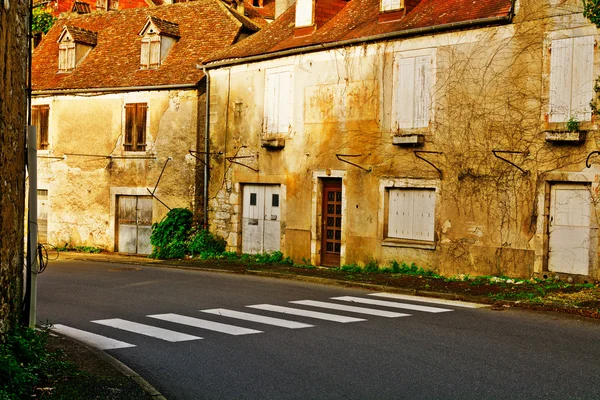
204, 0, 600, 279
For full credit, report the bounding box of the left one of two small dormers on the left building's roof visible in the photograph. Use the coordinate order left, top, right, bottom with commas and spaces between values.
58, 26, 97, 72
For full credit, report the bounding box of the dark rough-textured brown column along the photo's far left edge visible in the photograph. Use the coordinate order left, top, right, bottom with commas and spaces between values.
0, 1, 29, 333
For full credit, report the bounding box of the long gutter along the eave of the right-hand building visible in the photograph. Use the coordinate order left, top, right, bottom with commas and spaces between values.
202, 13, 514, 71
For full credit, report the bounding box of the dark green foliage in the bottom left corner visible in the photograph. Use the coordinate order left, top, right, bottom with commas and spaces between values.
0, 327, 73, 400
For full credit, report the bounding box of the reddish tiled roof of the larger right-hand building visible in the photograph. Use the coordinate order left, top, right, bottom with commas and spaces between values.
204, 0, 512, 63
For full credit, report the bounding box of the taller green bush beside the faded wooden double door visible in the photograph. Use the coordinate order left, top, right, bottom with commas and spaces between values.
150, 208, 192, 260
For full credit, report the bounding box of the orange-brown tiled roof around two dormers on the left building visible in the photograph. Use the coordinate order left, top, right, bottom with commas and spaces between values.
32, 0, 264, 91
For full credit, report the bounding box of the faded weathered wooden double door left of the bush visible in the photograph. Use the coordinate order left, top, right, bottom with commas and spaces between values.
117, 196, 152, 254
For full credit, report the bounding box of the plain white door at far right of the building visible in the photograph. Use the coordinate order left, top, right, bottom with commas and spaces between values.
548, 184, 591, 275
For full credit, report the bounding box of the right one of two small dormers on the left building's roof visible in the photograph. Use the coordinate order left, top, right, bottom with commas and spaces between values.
139, 16, 179, 69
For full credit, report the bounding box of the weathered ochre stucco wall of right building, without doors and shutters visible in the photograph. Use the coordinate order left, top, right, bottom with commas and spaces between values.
209, 0, 600, 278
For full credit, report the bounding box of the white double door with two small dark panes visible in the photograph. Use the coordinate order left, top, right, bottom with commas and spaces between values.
242, 185, 281, 254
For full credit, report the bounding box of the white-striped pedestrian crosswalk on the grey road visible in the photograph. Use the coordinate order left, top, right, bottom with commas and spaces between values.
52, 293, 481, 350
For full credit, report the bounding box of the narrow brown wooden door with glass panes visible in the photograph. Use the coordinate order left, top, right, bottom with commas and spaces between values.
321, 179, 342, 266
